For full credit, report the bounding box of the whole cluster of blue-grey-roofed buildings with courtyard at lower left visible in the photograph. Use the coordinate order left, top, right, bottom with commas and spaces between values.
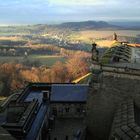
0, 83, 88, 140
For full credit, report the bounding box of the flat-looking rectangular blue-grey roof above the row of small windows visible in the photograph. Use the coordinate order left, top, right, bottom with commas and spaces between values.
51, 84, 88, 102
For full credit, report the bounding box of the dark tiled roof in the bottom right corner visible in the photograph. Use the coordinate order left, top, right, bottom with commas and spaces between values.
110, 100, 140, 140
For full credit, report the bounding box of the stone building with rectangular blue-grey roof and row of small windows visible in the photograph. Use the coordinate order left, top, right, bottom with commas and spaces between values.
50, 84, 88, 118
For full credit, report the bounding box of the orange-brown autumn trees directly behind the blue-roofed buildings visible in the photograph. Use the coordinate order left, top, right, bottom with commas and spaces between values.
0, 52, 89, 96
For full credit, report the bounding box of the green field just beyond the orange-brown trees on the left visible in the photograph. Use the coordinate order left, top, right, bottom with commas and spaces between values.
0, 55, 66, 67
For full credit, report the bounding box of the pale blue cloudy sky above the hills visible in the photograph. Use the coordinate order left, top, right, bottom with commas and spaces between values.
0, 0, 140, 25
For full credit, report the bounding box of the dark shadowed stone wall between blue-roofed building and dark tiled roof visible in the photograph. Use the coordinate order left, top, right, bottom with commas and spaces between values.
87, 74, 140, 140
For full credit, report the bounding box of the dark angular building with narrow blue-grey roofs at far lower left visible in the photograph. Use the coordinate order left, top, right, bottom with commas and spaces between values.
0, 84, 50, 140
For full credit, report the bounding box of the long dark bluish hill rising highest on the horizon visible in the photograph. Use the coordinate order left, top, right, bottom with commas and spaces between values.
51, 21, 121, 30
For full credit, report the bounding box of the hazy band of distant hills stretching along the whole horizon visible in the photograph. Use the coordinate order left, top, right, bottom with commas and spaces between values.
0, 21, 140, 37
